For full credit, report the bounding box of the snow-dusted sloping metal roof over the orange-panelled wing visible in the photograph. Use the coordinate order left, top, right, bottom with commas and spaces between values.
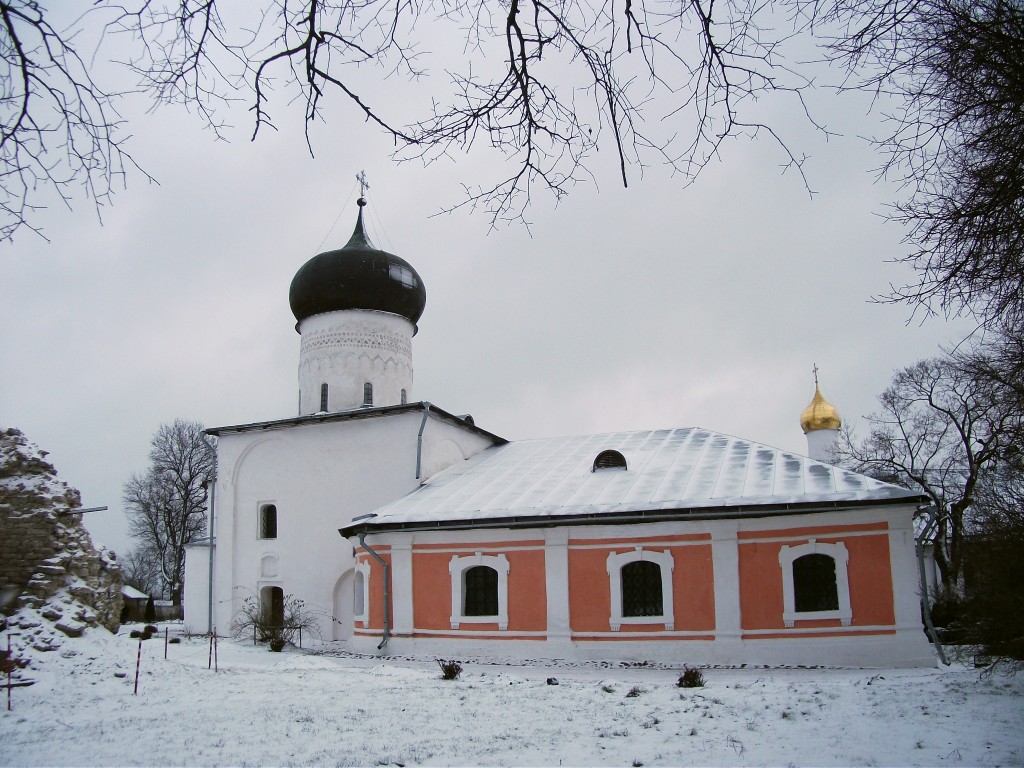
356, 427, 921, 532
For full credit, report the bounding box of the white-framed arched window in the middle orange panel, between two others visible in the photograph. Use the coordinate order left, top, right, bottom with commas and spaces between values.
607, 547, 676, 632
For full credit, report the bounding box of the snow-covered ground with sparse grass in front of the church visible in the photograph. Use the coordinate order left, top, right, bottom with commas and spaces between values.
0, 628, 1024, 766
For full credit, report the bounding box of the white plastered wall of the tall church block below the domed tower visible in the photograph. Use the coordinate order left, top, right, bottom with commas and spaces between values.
198, 411, 492, 639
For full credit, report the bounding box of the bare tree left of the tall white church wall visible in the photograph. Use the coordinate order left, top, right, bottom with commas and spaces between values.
123, 419, 215, 605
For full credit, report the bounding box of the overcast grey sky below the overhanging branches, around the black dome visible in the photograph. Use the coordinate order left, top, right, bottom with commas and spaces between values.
0, 10, 972, 552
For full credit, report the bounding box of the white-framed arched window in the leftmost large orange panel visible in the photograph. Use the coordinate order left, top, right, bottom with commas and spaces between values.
449, 552, 509, 630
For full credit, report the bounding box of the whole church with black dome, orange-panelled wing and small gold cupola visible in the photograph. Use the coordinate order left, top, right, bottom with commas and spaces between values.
184, 198, 934, 667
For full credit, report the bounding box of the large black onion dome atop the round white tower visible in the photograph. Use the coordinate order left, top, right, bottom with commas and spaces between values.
288, 198, 427, 326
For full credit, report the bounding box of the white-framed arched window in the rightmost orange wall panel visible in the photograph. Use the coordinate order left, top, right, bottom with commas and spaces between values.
778, 539, 853, 627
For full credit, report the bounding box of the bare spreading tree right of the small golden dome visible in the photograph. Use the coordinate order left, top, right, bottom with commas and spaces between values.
837, 357, 1021, 595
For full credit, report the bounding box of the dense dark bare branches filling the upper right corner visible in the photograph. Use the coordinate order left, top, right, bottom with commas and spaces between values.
814, 0, 1024, 327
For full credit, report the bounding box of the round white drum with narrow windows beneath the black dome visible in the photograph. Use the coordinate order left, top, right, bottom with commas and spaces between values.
299, 309, 416, 416
